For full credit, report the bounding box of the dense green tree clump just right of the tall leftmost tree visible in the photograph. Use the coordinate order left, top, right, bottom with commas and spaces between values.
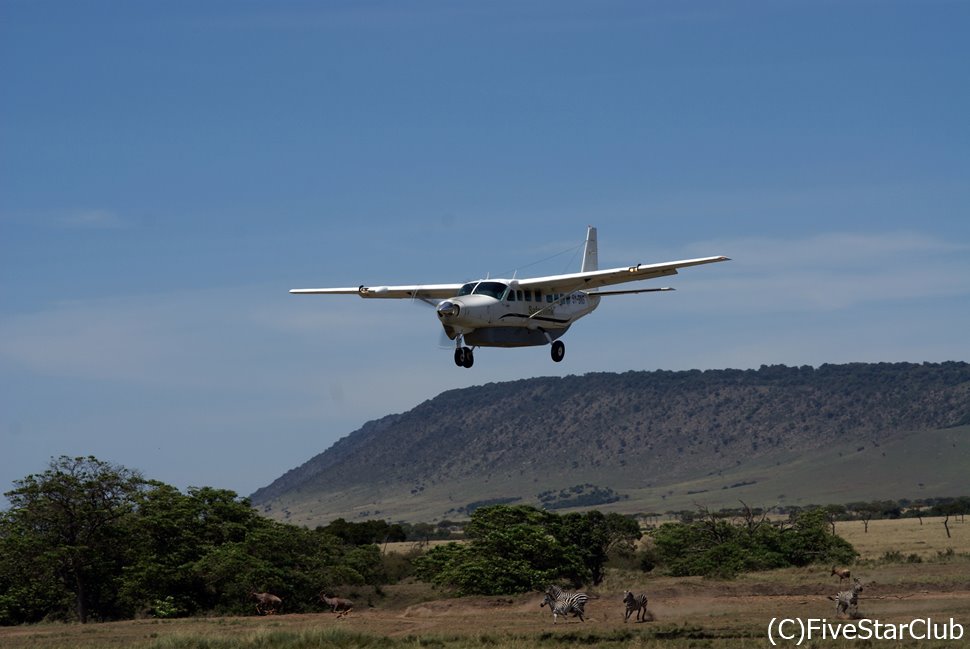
122, 483, 366, 616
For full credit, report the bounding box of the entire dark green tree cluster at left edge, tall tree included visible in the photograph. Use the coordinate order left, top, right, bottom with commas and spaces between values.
0, 457, 396, 624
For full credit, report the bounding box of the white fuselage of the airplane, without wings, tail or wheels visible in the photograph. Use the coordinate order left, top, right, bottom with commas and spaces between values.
436, 279, 600, 347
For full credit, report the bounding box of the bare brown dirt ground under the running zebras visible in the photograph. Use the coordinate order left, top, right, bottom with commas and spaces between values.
0, 560, 970, 649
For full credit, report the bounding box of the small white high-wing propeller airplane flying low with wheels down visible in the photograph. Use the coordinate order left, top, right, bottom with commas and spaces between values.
290, 226, 729, 367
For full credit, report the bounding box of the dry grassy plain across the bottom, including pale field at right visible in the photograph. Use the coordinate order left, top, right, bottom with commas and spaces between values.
0, 519, 970, 649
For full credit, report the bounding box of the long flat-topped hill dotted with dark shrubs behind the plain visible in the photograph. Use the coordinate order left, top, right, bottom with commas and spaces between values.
252, 362, 970, 525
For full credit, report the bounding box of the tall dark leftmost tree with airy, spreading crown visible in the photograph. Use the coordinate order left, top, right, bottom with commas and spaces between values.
0, 456, 143, 623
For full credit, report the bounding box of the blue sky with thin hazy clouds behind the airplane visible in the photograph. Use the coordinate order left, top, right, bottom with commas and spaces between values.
0, 0, 970, 504
